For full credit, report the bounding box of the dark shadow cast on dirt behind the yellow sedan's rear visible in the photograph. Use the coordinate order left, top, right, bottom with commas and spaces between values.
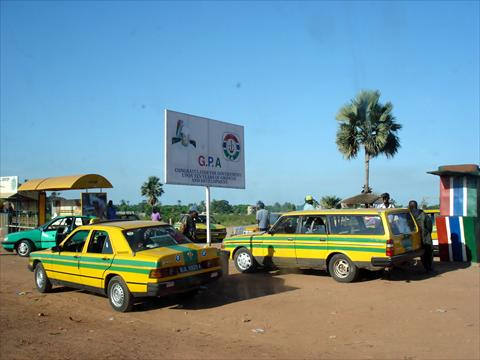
135, 272, 297, 311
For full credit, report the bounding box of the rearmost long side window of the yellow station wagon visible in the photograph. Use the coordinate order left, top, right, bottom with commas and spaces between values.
328, 214, 385, 235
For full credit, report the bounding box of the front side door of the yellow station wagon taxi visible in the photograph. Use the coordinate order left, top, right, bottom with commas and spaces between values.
262, 216, 299, 266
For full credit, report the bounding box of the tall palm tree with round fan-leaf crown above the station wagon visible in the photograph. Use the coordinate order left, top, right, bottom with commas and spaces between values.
336, 90, 402, 192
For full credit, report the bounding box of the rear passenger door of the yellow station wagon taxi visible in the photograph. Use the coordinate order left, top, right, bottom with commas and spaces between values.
295, 215, 327, 267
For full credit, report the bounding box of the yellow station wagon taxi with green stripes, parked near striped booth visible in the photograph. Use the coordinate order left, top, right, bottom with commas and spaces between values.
223, 209, 423, 282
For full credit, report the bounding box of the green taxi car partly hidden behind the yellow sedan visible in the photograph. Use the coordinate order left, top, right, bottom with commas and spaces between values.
2, 215, 92, 257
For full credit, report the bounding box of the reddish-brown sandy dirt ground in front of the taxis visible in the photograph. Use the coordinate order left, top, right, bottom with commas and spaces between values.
0, 253, 480, 359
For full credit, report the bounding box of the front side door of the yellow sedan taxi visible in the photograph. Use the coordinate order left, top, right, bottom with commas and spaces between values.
52, 230, 90, 284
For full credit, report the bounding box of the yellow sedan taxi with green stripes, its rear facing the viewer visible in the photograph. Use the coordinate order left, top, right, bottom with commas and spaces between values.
29, 221, 221, 312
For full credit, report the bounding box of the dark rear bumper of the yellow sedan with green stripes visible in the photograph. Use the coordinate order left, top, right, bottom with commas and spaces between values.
139, 269, 222, 296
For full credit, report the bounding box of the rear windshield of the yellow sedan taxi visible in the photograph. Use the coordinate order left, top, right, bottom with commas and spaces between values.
123, 226, 191, 252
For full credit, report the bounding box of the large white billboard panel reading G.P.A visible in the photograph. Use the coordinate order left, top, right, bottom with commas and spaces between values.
165, 110, 245, 189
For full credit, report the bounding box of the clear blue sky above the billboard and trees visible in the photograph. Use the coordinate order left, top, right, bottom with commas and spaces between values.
0, 1, 480, 204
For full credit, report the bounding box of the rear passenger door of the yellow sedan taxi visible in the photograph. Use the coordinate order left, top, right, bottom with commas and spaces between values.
79, 230, 114, 288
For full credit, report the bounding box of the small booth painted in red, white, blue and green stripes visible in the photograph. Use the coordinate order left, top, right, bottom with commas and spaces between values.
429, 164, 480, 262
